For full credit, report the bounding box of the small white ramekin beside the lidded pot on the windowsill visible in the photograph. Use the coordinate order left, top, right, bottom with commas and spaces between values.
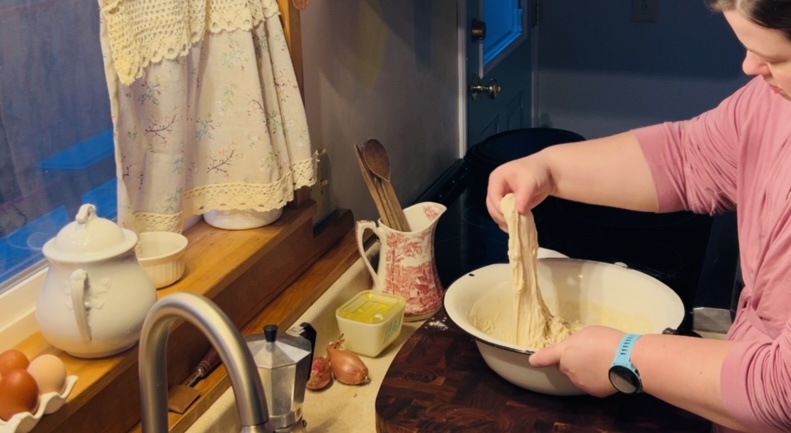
135, 231, 187, 289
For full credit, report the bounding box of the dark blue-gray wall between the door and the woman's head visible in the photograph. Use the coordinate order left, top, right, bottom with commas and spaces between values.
536, 0, 746, 138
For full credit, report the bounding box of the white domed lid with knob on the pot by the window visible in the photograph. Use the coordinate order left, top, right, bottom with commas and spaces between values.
42, 203, 137, 262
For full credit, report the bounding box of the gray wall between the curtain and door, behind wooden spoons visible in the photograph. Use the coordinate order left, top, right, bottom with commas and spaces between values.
302, 0, 461, 219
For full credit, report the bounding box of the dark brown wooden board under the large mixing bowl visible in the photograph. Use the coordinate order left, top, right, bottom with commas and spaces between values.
375, 310, 711, 433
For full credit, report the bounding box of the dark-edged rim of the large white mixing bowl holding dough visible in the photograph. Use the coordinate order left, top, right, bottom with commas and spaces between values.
442, 256, 685, 355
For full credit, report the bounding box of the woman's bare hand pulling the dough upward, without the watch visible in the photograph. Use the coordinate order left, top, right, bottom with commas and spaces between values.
486, 152, 555, 231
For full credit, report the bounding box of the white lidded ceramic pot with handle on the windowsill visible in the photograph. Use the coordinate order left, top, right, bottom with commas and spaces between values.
36, 204, 157, 358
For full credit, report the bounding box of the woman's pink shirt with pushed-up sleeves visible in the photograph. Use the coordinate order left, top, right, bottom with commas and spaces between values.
635, 78, 791, 433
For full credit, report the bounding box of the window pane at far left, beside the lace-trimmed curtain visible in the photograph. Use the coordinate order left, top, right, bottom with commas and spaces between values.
0, 0, 116, 344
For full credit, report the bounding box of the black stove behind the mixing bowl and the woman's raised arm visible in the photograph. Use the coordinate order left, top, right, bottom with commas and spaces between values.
416, 128, 712, 333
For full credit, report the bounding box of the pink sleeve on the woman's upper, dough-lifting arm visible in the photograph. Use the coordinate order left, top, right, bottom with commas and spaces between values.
633, 81, 758, 215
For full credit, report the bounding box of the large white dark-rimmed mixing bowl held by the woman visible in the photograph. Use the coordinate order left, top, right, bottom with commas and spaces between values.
444, 258, 684, 395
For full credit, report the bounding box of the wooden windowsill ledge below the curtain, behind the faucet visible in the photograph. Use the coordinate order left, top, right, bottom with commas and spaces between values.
18, 201, 358, 433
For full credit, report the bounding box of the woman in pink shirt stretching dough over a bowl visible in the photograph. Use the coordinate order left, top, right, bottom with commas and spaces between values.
486, 0, 791, 433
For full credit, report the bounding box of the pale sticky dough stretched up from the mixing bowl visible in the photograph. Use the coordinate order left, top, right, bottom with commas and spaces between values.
500, 193, 579, 349
